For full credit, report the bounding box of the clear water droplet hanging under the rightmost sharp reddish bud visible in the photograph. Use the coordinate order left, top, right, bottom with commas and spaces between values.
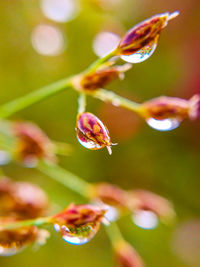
146, 118, 180, 131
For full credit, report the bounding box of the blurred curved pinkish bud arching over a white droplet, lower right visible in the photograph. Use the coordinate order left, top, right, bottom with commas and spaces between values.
127, 190, 175, 223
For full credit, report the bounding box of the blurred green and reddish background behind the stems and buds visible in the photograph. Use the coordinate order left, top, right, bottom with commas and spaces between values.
0, 0, 200, 267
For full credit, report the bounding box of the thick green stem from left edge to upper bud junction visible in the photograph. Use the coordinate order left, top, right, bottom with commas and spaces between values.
0, 78, 71, 118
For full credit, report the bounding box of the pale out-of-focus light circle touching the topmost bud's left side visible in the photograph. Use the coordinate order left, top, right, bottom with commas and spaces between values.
93, 31, 120, 57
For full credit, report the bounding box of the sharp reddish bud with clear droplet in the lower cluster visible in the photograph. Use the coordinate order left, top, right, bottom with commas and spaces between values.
52, 204, 106, 245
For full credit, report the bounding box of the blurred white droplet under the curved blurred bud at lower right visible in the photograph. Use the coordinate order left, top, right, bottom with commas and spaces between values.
132, 210, 158, 229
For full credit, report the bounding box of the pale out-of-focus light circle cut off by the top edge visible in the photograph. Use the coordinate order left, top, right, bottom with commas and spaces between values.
41, 0, 79, 22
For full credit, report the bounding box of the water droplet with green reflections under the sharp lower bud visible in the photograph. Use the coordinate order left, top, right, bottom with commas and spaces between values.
54, 222, 100, 245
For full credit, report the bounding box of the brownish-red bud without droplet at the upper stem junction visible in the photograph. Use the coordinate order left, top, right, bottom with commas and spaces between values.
73, 63, 132, 91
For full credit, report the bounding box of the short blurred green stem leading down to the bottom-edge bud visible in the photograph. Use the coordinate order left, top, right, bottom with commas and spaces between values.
105, 222, 124, 248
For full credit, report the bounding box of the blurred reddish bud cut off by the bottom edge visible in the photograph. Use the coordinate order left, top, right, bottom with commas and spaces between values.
115, 241, 144, 267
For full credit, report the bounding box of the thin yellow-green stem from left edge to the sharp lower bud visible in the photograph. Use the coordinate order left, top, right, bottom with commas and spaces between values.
0, 217, 51, 231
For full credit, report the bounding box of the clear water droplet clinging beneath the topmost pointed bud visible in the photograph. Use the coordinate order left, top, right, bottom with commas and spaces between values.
121, 42, 157, 63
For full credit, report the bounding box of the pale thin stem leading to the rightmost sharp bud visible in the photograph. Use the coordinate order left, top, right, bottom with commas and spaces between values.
86, 89, 141, 113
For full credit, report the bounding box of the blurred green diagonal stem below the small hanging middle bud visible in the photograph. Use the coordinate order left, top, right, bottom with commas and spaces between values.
37, 161, 92, 198
